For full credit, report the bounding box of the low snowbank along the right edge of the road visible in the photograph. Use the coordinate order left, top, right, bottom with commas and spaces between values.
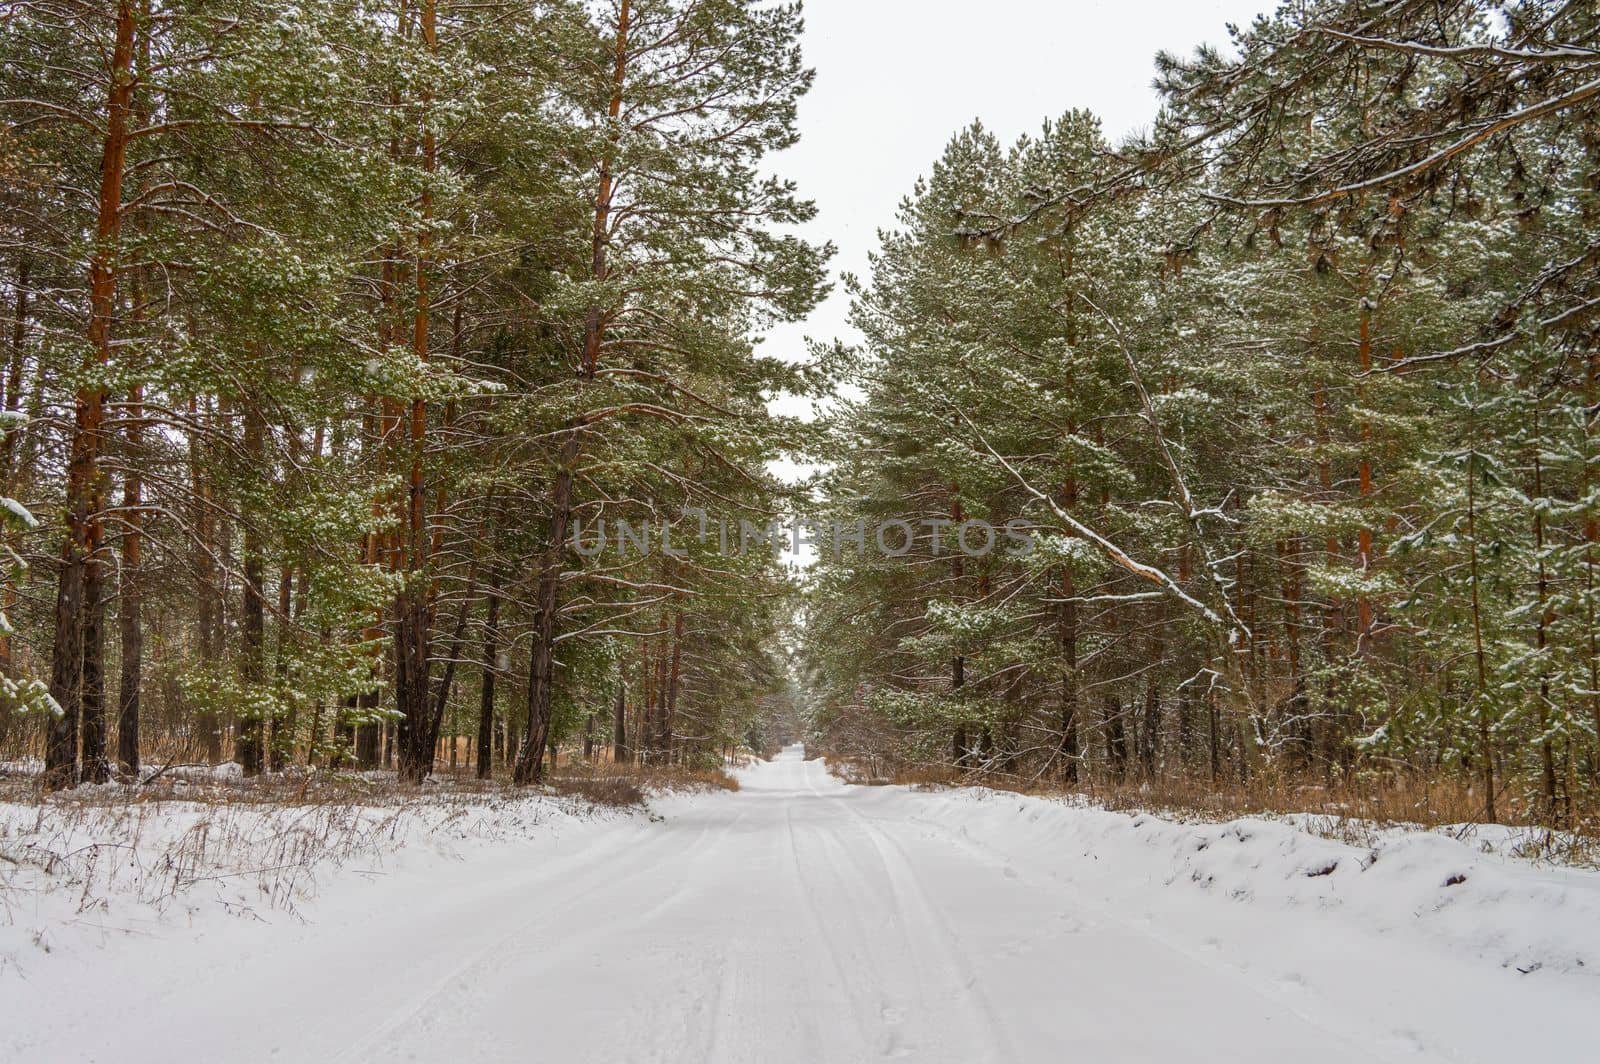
896, 790, 1600, 976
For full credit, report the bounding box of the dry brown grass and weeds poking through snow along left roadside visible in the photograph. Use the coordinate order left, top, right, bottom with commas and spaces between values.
0, 773, 642, 922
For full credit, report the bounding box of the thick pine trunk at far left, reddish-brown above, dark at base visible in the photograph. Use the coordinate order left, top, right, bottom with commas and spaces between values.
45, 0, 136, 787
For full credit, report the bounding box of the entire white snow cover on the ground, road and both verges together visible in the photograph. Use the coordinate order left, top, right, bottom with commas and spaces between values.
0, 749, 1600, 1064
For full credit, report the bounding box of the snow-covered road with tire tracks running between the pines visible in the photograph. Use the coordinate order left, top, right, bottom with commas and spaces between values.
0, 749, 1600, 1064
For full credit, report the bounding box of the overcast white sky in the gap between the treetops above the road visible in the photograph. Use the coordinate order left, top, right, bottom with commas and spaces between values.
763, 0, 1275, 413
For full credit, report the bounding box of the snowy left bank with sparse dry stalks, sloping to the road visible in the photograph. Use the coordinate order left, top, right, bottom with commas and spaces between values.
0, 782, 626, 981
